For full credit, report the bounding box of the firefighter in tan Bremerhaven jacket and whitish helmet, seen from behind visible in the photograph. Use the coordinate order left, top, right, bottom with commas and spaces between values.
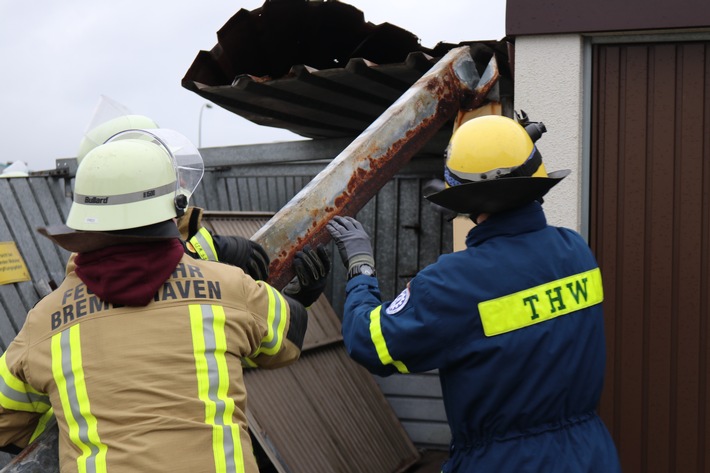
0, 130, 322, 473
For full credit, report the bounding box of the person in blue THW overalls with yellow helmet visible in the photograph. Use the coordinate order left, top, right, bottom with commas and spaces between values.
327, 116, 620, 473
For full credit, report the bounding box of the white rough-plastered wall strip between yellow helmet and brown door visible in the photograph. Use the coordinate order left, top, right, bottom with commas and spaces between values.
514, 35, 589, 231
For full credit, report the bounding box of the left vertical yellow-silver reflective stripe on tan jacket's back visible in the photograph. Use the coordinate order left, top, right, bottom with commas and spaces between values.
52, 324, 108, 473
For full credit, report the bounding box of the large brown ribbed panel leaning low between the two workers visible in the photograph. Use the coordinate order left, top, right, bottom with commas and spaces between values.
245, 346, 419, 473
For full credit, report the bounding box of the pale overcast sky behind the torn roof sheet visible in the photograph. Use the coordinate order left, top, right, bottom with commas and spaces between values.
0, 0, 505, 171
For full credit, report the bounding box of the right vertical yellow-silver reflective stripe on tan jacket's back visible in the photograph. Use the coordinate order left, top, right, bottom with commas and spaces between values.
190, 304, 244, 473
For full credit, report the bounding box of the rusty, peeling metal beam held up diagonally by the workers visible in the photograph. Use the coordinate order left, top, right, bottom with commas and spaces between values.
252, 46, 498, 289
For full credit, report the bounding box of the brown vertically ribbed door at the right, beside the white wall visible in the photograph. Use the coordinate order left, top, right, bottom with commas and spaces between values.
590, 42, 710, 473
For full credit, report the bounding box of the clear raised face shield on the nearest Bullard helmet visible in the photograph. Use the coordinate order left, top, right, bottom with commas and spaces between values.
107, 128, 205, 206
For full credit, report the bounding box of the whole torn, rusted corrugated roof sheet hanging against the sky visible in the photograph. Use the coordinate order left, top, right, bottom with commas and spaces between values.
182, 0, 509, 138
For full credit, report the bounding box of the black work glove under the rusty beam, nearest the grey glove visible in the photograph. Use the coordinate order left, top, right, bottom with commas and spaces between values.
282, 245, 330, 307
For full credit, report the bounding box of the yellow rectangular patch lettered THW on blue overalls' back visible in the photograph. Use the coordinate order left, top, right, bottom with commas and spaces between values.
478, 268, 604, 337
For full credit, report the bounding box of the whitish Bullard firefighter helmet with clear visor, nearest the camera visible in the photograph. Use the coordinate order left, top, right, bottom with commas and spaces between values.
66, 129, 204, 231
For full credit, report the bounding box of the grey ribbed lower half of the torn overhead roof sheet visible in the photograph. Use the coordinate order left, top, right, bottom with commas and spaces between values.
183, 53, 436, 138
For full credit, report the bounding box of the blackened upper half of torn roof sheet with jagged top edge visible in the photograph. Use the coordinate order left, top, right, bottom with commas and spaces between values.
181, 0, 430, 86
